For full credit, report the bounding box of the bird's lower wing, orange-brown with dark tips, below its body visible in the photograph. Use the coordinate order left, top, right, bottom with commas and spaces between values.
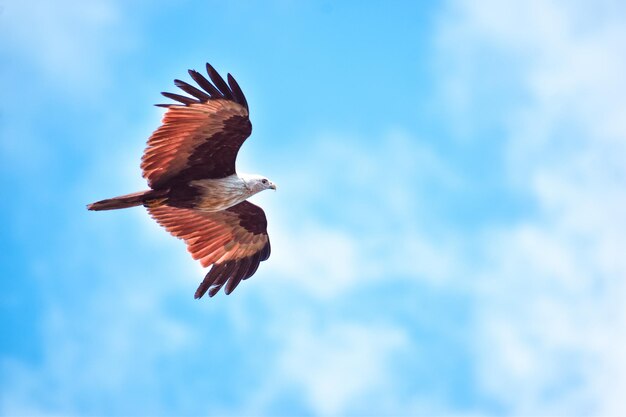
148, 201, 270, 298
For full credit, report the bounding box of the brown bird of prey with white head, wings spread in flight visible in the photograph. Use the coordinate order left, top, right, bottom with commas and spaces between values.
87, 63, 276, 298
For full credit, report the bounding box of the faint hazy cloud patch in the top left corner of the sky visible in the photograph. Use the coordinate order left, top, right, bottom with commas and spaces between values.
0, 0, 127, 91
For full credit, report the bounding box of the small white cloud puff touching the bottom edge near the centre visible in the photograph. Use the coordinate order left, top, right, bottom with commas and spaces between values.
279, 322, 408, 415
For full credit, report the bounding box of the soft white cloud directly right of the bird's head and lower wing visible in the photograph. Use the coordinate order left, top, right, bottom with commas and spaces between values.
259, 132, 463, 299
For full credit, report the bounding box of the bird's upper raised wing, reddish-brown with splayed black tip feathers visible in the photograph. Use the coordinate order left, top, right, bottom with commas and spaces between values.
141, 64, 252, 188
